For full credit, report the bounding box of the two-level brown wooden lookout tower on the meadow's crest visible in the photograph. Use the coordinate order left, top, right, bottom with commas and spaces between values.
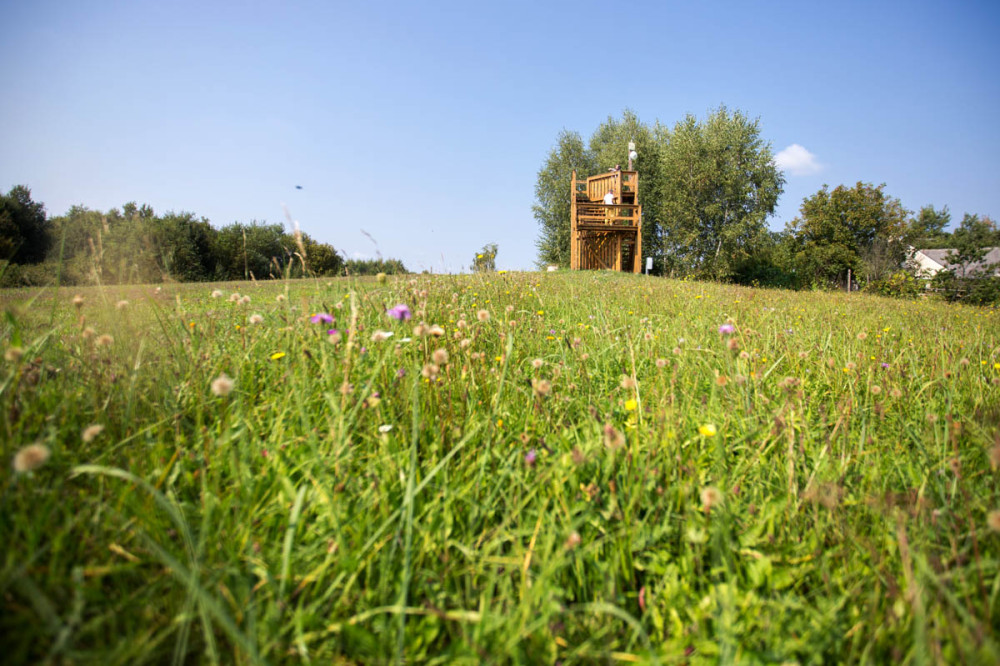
569, 165, 642, 273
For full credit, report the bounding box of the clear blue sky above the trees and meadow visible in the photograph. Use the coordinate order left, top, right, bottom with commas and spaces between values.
0, 0, 1000, 271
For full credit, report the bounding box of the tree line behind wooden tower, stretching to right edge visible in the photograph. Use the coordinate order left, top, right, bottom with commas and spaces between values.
533, 106, 1000, 300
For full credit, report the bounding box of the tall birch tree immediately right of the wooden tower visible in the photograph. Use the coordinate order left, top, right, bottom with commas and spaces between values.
660, 106, 785, 279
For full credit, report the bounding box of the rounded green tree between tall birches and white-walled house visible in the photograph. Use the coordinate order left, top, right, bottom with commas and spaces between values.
787, 182, 909, 286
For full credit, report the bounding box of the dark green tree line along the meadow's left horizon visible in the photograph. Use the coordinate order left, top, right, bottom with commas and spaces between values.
0, 185, 408, 286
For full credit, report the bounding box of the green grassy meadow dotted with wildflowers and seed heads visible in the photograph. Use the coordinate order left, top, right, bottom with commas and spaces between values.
0, 272, 1000, 664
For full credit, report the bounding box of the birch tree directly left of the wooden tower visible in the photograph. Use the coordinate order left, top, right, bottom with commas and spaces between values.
531, 130, 594, 268
